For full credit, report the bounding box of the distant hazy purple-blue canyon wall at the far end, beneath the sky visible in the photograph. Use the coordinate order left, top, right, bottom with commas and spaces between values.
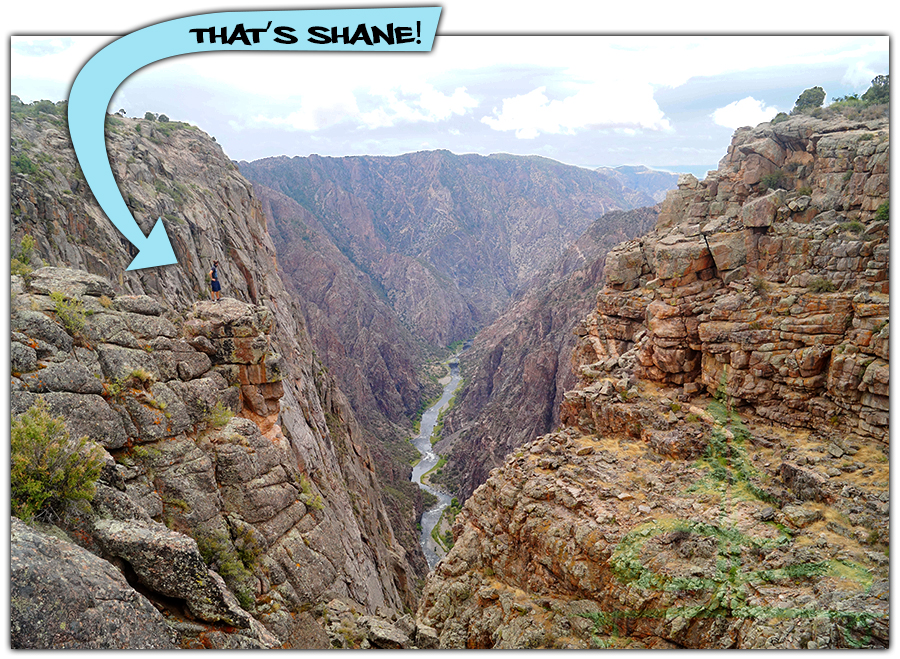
240, 151, 652, 346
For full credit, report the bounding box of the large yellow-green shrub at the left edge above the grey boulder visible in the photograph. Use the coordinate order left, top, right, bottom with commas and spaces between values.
10, 398, 104, 521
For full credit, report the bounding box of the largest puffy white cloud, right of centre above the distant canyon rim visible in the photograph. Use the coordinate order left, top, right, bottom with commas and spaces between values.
481, 80, 671, 139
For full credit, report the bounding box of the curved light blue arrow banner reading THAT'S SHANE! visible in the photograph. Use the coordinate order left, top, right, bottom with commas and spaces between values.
69, 7, 441, 270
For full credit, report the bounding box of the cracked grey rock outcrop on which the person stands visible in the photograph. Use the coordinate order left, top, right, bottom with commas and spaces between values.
11, 268, 408, 647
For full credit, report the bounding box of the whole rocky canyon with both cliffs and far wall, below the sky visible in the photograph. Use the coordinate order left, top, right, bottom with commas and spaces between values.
11, 94, 889, 648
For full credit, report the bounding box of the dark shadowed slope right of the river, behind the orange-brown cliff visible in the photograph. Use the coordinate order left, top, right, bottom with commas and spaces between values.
436, 207, 657, 500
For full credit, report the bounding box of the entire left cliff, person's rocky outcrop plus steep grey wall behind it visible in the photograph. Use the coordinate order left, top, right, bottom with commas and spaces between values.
11, 99, 424, 647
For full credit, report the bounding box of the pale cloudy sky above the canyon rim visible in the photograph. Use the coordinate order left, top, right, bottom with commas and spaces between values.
10, 2, 889, 174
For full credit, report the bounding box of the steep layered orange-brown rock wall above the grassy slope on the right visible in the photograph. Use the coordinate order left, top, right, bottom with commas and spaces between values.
581, 113, 890, 441
